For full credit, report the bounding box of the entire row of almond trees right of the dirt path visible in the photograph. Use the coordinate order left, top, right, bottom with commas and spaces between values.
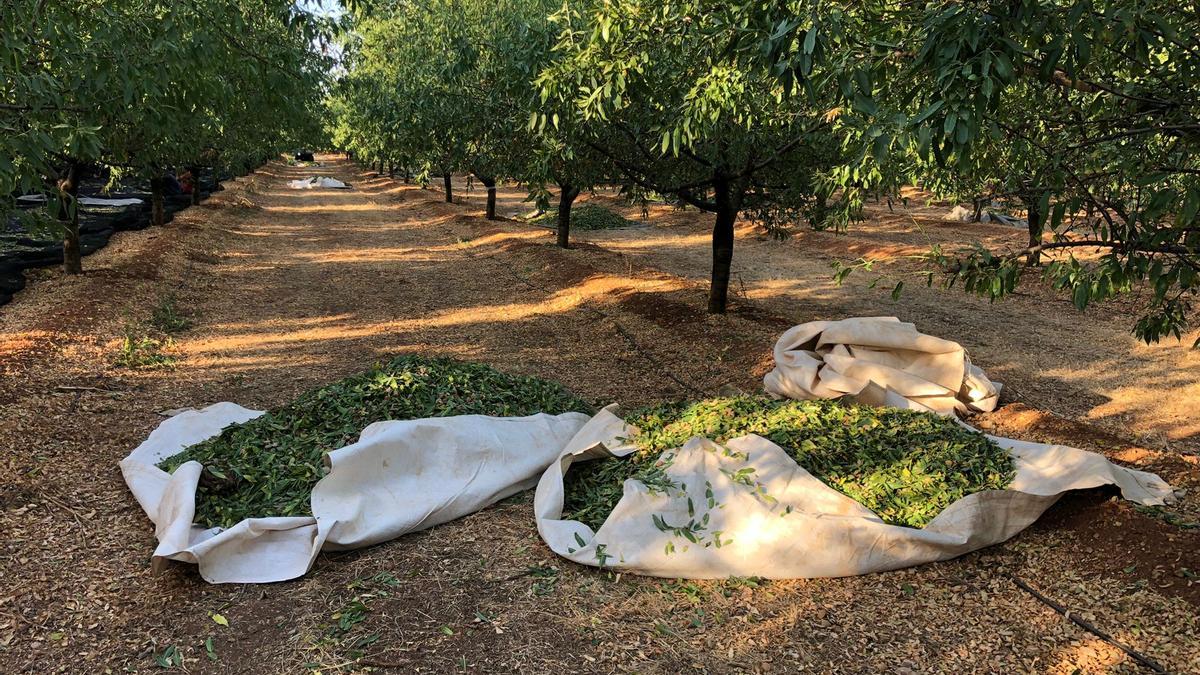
329, 0, 1200, 341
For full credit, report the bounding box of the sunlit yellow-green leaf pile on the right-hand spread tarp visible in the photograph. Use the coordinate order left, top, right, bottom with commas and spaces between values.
563, 396, 1015, 530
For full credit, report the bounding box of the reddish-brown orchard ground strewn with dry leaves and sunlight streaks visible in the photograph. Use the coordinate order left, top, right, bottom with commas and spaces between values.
0, 157, 1200, 673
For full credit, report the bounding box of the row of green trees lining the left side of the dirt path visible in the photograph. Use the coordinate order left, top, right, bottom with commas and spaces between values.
0, 0, 331, 273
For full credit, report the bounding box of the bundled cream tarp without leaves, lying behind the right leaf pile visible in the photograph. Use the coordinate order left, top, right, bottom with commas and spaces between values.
763, 317, 1001, 414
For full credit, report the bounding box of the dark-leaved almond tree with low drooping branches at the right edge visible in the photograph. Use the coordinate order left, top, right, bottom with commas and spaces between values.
730, 0, 1200, 341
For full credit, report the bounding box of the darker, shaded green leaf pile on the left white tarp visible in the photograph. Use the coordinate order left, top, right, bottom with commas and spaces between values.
158, 356, 592, 527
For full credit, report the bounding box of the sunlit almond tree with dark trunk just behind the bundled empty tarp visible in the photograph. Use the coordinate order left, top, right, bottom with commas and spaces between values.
539, 0, 864, 313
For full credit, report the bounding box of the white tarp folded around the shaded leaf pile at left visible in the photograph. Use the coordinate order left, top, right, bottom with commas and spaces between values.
121, 402, 588, 584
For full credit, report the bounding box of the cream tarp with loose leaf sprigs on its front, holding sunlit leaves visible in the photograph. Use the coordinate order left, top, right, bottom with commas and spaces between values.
534, 410, 1174, 579
